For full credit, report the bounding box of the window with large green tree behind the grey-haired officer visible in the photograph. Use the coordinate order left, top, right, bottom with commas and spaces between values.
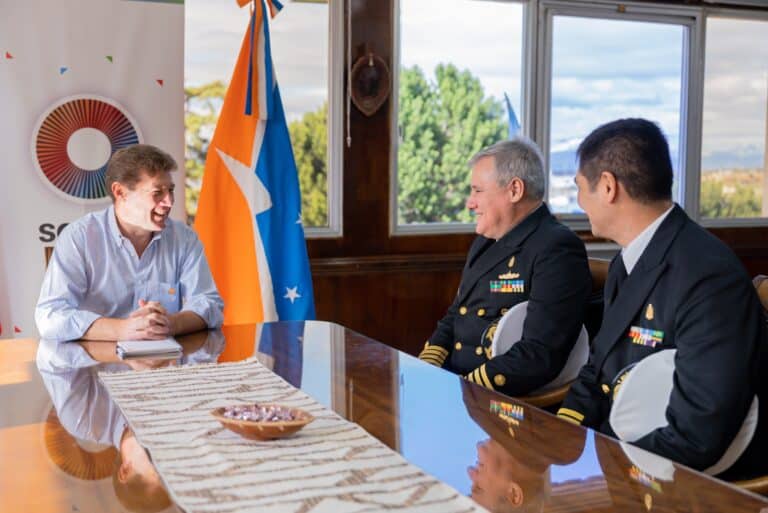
392, 0, 524, 233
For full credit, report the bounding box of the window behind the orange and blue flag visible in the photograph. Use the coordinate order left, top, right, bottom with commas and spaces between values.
185, 0, 343, 237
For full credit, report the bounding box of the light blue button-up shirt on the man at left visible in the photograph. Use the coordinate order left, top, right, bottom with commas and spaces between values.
35, 206, 224, 341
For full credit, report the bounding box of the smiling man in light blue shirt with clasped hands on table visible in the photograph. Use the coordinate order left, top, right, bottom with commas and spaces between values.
35, 144, 223, 340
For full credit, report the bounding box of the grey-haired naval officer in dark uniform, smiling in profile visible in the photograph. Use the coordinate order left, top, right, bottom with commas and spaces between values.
419, 137, 591, 396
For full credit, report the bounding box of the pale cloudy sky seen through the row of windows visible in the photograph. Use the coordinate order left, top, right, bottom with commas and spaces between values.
185, 0, 768, 169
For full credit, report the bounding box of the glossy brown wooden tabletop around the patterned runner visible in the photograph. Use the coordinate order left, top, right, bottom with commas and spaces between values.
0, 322, 768, 513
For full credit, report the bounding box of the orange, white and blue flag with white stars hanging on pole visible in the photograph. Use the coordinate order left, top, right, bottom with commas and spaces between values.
195, 0, 315, 325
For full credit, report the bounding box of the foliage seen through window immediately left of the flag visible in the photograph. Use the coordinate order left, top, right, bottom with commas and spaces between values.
184, 80, 227, 219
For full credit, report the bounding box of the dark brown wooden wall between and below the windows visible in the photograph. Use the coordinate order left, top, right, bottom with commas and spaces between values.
308, 0, 768, 354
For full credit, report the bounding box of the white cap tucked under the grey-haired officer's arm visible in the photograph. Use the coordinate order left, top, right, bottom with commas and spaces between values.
491, 301, 589, 394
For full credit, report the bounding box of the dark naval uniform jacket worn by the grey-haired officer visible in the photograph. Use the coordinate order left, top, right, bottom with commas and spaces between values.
419, 204, 591, 395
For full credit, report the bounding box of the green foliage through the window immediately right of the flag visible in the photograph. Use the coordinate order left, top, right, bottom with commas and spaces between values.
288, 102, 328, 226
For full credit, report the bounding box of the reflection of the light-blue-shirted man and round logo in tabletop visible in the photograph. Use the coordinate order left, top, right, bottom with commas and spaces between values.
36, 331, 224, 512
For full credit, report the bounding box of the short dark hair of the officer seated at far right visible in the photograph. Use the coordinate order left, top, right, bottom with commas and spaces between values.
576, 118, 673, 203
